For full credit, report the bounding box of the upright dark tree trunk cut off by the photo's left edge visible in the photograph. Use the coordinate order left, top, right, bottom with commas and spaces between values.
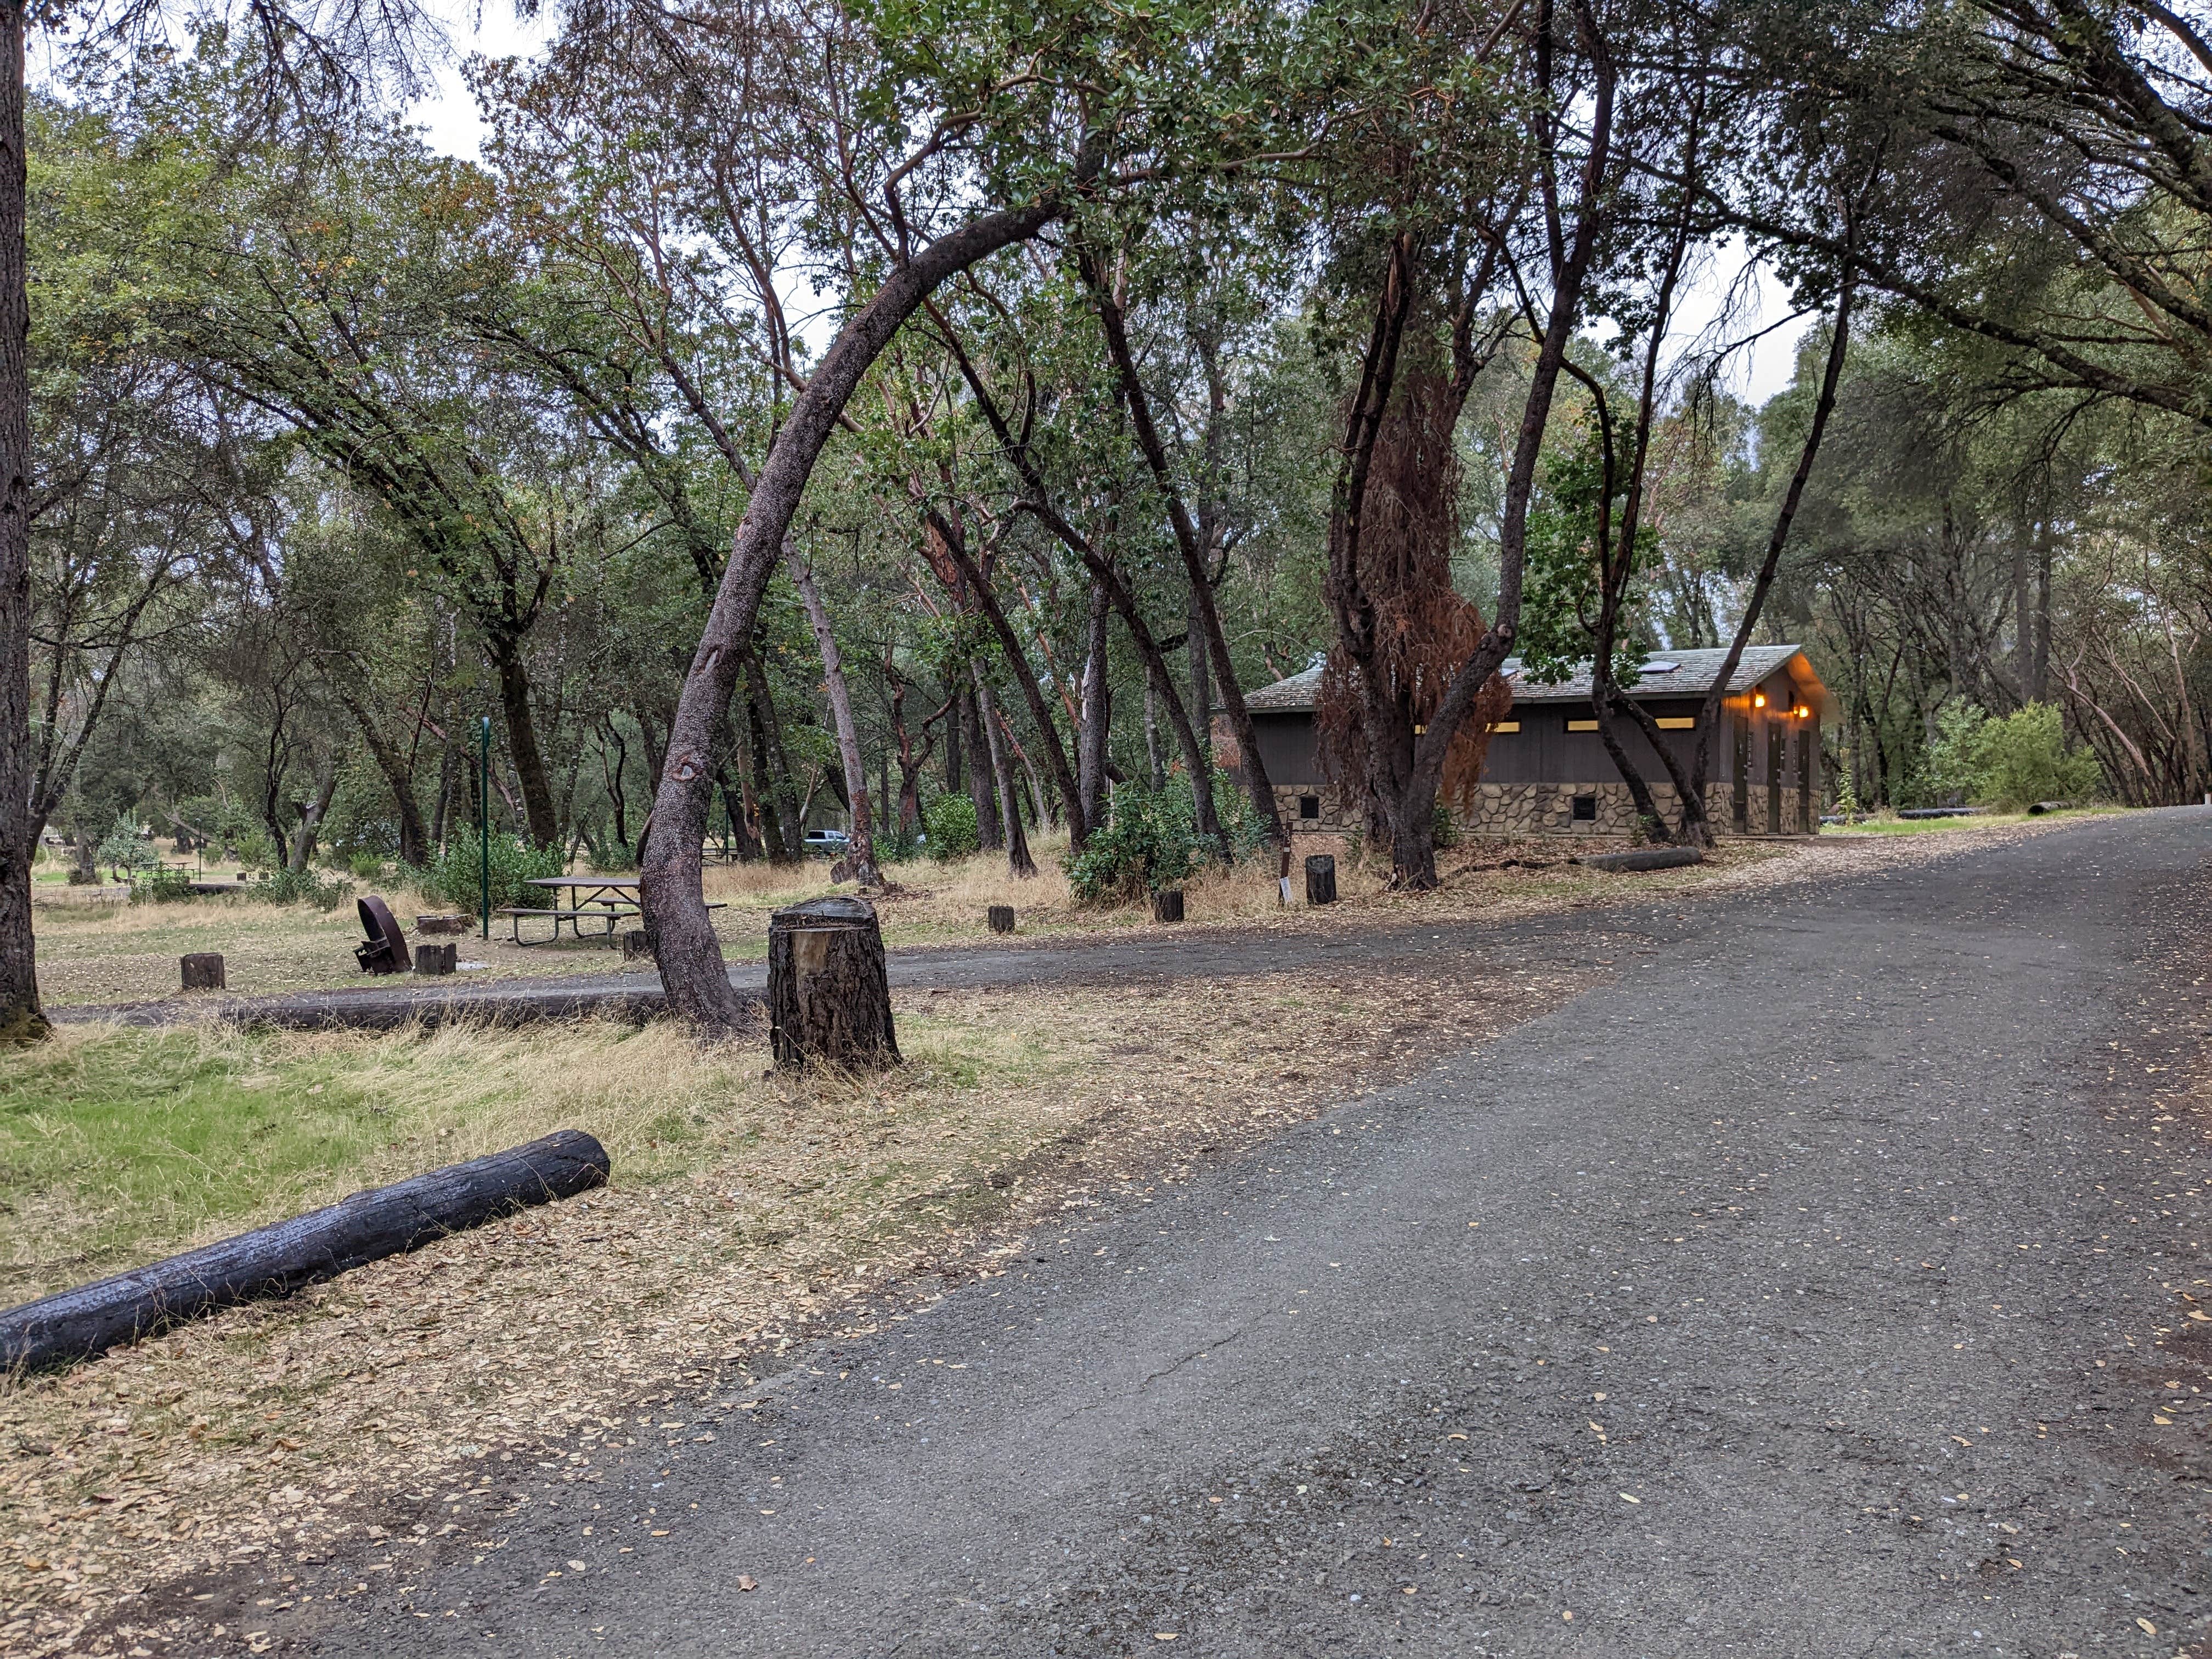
0, 0, 47, 1042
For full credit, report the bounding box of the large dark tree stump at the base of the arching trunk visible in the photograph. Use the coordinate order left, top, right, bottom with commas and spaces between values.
768, 898, 898, 1066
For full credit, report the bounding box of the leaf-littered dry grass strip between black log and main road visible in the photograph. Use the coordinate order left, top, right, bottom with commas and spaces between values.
0, 971, 1573, 1652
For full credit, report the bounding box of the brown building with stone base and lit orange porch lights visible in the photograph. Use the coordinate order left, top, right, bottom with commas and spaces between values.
1245, 646, 1834, 836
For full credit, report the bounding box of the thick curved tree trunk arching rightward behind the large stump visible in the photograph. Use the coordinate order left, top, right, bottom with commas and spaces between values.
637, 188, 1084, 1031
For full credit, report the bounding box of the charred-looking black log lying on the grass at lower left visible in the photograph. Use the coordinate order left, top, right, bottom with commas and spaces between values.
0, 1128, 611, 1369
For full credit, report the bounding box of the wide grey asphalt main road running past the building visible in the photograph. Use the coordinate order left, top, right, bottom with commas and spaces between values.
287, 810, 2212, 1659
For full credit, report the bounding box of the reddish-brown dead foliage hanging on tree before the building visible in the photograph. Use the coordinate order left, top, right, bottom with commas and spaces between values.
1314, 369, 1513, 845
